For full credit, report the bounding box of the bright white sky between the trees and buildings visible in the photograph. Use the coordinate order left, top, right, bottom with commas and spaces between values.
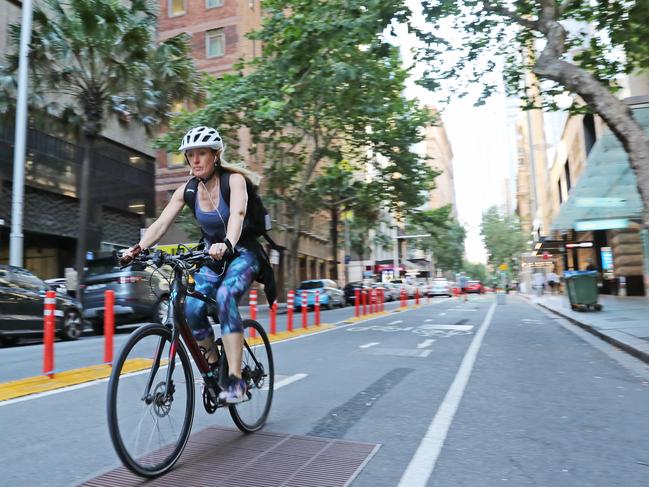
397, 0, 515, 263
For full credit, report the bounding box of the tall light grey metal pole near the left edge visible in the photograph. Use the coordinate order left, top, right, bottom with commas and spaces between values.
9, 0, 32, 267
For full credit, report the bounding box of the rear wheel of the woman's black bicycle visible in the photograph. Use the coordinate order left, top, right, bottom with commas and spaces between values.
229, 320, 275, 433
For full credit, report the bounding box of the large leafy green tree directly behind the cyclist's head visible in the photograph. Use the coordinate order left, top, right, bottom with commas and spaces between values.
163, 0, 434, 290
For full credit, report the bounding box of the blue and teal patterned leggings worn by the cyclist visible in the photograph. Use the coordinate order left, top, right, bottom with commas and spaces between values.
185, 247, 259, 340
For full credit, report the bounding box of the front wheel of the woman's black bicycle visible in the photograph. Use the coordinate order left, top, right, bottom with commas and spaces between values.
107, 324, 194, 477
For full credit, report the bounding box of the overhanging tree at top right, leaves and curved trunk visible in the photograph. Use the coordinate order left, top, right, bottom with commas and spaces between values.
419, 0, 649, 227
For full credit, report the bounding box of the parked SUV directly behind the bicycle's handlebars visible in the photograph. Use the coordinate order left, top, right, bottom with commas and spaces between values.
80, 256, 169, 335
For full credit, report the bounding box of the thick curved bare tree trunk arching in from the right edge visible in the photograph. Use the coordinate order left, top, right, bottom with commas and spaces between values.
533, 20, 649, 228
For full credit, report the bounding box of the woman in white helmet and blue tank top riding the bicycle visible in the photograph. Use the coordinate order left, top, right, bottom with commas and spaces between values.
123, 127, 274, 403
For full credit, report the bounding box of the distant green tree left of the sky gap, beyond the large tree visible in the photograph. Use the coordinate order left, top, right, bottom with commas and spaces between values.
406, 205, 466, 272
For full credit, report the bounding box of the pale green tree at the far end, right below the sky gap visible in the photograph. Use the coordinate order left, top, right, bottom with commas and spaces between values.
480, 206, 527, 269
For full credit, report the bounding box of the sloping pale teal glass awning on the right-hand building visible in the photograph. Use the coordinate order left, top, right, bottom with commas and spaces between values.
550, 107, 649, 231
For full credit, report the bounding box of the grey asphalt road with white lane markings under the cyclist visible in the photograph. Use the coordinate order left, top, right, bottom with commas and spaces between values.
0, 296, 649, 487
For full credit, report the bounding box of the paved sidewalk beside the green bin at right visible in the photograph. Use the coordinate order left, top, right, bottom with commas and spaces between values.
525, 294, 649, 363
